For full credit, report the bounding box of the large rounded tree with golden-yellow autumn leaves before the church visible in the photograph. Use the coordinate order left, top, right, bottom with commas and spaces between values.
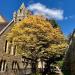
7, 16, 67, 72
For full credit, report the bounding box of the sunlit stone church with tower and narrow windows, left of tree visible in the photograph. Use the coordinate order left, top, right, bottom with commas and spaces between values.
0, 3, 34, 75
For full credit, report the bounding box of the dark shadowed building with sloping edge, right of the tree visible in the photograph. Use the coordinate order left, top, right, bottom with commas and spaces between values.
63, 30, 75, 75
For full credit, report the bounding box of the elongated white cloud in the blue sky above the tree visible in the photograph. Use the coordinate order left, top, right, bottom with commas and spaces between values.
28, 3, 64, 20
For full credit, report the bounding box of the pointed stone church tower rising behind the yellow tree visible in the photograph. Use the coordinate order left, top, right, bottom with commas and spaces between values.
13, 3, 31, 23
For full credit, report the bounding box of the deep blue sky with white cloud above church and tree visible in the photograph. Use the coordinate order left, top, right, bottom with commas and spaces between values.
0, 0, 75, 35
